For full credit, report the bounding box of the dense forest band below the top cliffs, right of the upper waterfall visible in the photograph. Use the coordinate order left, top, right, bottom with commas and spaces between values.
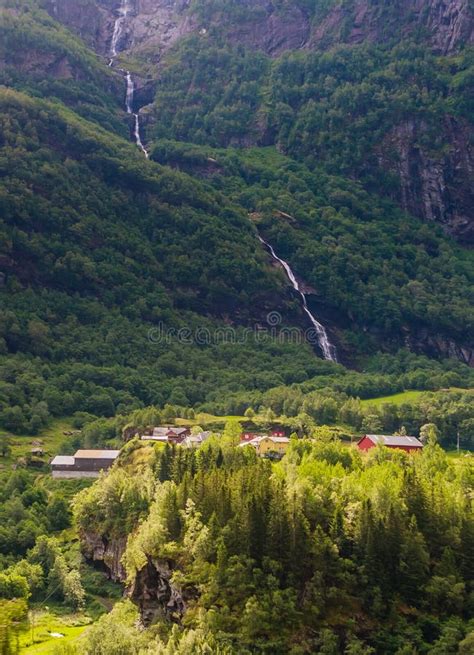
149, 37, 474, 174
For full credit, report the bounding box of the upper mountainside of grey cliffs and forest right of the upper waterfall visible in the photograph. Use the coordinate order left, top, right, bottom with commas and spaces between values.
34, 0, 474, 243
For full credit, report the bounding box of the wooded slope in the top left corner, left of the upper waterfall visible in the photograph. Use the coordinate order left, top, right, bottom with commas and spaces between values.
0, 0, 127, 137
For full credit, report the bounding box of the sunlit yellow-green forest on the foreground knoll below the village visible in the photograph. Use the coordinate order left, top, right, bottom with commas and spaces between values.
74, 435, 474, 654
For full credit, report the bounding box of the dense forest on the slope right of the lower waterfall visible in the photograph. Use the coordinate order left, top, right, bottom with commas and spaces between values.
152, 141, 474, 353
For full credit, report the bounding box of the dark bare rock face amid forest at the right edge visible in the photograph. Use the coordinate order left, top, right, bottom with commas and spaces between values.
378, 117, 474, 243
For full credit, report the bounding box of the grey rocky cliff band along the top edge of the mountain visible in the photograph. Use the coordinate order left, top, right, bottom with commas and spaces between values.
43, 0, 474, 61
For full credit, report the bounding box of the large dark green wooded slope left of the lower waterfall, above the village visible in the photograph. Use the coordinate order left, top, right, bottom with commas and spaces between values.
0, 83, 340, 433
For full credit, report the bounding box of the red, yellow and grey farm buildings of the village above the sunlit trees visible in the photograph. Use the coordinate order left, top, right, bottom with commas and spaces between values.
51, 425, 423, 478
